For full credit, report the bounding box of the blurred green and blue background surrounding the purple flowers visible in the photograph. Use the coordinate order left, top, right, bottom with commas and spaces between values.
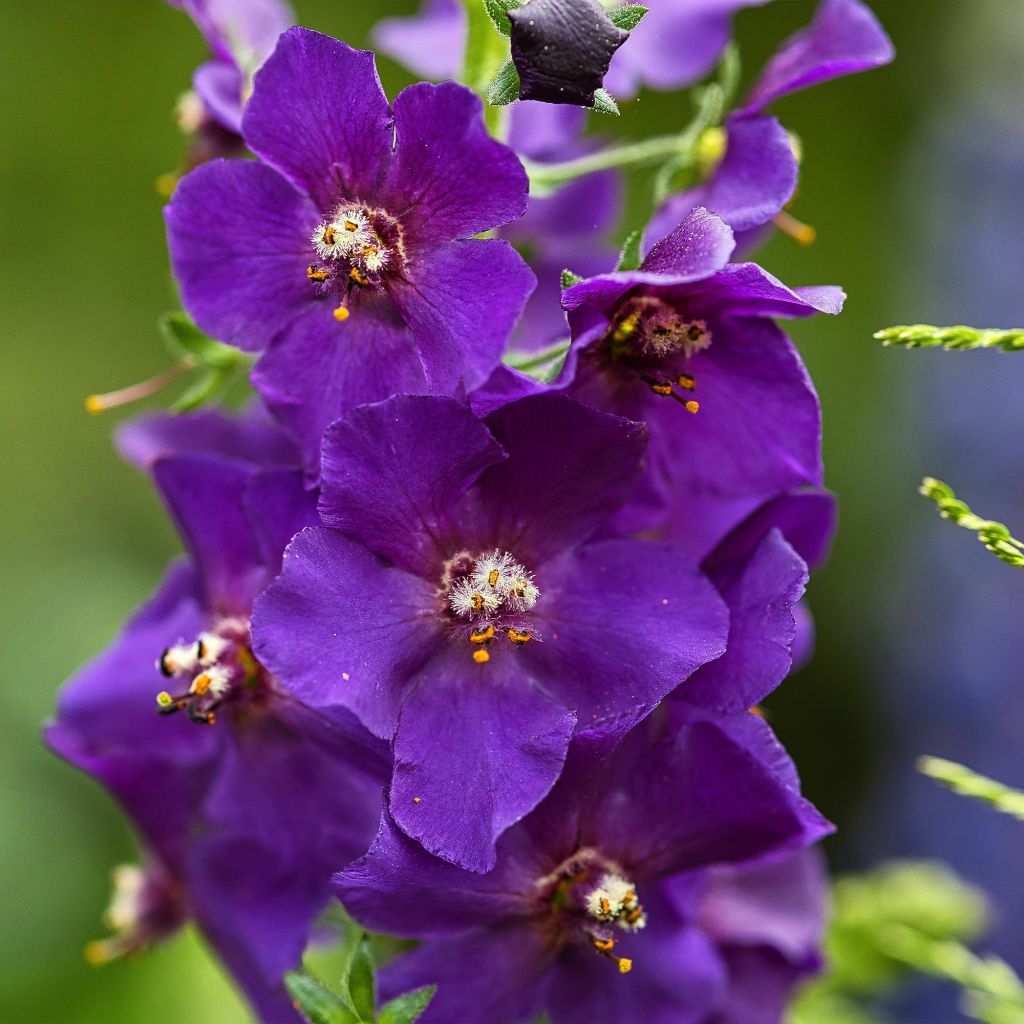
0, 0, 1024, 1024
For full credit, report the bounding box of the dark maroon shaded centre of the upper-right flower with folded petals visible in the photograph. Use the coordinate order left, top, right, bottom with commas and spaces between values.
602, 295, 712, 413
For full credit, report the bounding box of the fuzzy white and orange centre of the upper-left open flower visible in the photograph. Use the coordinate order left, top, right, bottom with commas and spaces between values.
306, 203, 404, 322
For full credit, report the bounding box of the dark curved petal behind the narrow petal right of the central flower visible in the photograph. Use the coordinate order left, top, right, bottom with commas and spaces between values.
701, 490, 837, 585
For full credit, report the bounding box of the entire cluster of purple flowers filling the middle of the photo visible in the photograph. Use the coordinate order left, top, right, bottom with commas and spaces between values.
47, 0, 890, 1024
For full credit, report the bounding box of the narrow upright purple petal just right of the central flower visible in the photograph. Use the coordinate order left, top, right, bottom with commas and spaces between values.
685, 529, 807, 712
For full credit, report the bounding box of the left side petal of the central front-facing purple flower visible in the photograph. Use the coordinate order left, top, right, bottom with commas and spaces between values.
252, 526, 438, 739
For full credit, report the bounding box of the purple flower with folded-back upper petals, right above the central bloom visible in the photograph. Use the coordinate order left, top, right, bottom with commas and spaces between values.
473, 209, 843, 505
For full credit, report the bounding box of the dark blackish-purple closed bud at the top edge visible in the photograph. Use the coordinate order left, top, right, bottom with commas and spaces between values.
509, 0, 630, 106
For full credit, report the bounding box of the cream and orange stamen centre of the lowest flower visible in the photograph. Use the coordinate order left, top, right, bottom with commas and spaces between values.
538, 849, 647, 974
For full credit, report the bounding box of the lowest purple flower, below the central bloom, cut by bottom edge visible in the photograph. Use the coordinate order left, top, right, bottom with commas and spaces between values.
335, 703, 829, 1024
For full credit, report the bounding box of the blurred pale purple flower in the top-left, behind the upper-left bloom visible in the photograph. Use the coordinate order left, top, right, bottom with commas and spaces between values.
167, 0, 295, 167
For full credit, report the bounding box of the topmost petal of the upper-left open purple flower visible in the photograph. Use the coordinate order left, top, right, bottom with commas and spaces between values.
242, 29, 392, 207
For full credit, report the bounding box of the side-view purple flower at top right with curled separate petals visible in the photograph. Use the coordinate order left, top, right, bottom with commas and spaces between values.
651, 0, 894, 242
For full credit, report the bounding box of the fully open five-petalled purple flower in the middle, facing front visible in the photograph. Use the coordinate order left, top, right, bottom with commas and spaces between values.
247, 395, 726, 870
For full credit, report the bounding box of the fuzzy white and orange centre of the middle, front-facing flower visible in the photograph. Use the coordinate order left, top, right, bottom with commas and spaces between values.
440, 548, 541, 665
